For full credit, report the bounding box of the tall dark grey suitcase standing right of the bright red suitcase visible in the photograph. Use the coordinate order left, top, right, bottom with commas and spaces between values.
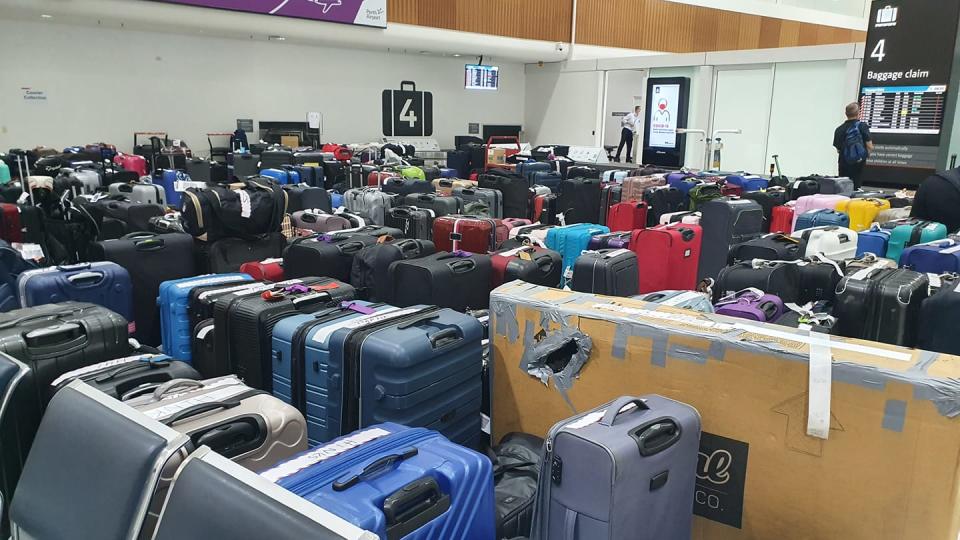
697, 197, 763, 280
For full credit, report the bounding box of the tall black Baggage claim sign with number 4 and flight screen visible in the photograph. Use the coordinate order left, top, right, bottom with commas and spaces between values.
860, 0, 960, 185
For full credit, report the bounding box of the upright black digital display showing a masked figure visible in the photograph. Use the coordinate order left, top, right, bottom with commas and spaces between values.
643, 77, 690, 167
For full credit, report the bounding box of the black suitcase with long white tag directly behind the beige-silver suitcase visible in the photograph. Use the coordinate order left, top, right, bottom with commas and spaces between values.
51, 354, 200, 400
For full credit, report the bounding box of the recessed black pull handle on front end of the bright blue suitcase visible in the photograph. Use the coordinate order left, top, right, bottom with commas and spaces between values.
383, 476, 450, 540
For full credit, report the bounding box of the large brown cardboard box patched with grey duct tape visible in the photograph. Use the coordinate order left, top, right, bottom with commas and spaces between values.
491, 282, 960, 540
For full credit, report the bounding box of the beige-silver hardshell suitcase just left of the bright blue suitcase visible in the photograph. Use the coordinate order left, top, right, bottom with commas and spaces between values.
126, 376, 307, 471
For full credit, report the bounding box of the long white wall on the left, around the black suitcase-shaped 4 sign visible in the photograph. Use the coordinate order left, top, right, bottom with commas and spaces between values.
0, 20, 524, 152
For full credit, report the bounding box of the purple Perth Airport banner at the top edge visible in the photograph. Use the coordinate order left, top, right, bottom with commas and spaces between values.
157, 0, 387, 28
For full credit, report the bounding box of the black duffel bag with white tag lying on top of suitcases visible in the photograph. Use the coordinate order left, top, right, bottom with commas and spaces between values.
180, 176, 287, 242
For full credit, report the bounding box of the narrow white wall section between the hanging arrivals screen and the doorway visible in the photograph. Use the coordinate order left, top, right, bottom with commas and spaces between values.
524, 64, 603, 146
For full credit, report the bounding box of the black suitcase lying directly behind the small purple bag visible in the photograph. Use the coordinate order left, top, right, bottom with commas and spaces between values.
713, 261, 800, 302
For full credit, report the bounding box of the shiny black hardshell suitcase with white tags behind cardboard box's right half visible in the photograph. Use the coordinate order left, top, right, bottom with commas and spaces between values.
833, 268, 930, 347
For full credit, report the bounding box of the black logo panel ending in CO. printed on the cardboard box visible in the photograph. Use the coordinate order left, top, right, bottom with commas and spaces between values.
693, 432, 750, 529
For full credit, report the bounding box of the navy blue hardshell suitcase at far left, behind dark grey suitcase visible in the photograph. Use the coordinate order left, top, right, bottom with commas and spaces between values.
17, 262, 133, 324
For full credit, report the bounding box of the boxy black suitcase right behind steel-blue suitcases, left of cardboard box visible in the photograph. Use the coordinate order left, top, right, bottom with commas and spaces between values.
390, 252, 492, 311
